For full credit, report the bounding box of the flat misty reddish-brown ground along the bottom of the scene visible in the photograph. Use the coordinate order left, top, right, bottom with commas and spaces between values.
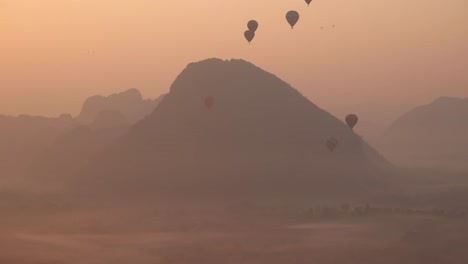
0, 199, 468, 264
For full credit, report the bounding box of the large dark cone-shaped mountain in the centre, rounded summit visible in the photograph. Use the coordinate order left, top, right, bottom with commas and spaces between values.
73, 59, 393, 201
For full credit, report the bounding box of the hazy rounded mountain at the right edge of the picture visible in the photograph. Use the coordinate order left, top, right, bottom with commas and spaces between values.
377, 97, 468, 169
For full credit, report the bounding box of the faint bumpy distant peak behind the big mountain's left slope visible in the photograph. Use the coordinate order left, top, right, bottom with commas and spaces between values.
77, 89, 164, 124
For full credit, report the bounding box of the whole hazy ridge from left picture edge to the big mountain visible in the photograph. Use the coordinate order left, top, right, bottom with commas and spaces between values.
0, 89, 163, 178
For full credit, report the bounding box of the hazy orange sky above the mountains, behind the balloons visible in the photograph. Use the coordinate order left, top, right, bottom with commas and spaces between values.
0, 0, 468, 115
